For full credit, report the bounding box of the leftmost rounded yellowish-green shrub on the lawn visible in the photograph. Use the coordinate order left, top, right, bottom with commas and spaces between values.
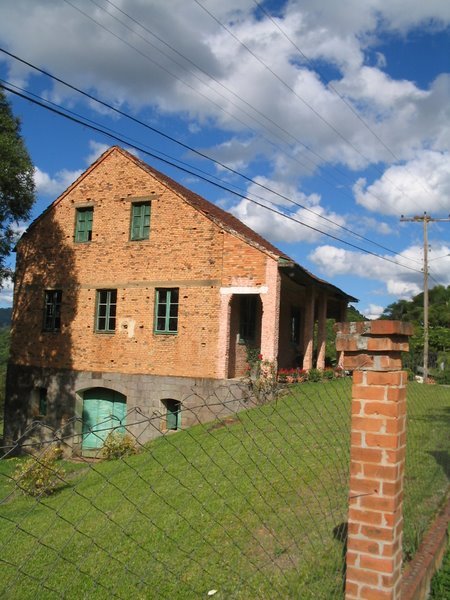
13, 445, 66, 496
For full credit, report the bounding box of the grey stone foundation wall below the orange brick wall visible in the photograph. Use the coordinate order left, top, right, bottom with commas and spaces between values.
4, 364, 252, 454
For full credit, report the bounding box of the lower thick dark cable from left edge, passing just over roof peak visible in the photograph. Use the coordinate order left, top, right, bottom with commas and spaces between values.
1, 83, 420, 273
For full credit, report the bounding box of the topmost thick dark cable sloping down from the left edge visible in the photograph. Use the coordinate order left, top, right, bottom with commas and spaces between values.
0, 48, 417, 262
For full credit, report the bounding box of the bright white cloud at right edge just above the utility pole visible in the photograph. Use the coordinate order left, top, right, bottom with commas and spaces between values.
353, 150, 450, 216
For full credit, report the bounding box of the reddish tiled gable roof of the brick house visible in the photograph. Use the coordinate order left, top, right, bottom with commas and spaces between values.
25, 146, 357, 302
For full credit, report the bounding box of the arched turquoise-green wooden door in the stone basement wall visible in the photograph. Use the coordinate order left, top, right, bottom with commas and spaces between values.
82, 388, 127, 450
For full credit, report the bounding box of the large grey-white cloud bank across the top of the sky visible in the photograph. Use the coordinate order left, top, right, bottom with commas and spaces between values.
0, 0, 450, 176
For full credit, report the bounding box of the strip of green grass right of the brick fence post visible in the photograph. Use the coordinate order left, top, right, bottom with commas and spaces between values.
403, 381, 450, 560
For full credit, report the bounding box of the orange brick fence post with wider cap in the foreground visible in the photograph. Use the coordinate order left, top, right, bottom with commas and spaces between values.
335, 321, 412, 600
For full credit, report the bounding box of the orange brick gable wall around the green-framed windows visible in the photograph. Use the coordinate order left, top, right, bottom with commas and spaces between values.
11, 151, 273, 377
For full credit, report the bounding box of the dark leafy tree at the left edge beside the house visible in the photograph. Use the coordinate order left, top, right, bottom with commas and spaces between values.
0, 88, 35, 286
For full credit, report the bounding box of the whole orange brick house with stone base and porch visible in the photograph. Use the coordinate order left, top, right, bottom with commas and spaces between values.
5, 147, 355, 450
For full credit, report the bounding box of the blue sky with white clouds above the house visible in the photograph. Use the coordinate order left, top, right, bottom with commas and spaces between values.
0, 0, 450, 318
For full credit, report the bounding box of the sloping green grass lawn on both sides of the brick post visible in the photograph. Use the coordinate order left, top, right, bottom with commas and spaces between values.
0, 380, 450, 600
